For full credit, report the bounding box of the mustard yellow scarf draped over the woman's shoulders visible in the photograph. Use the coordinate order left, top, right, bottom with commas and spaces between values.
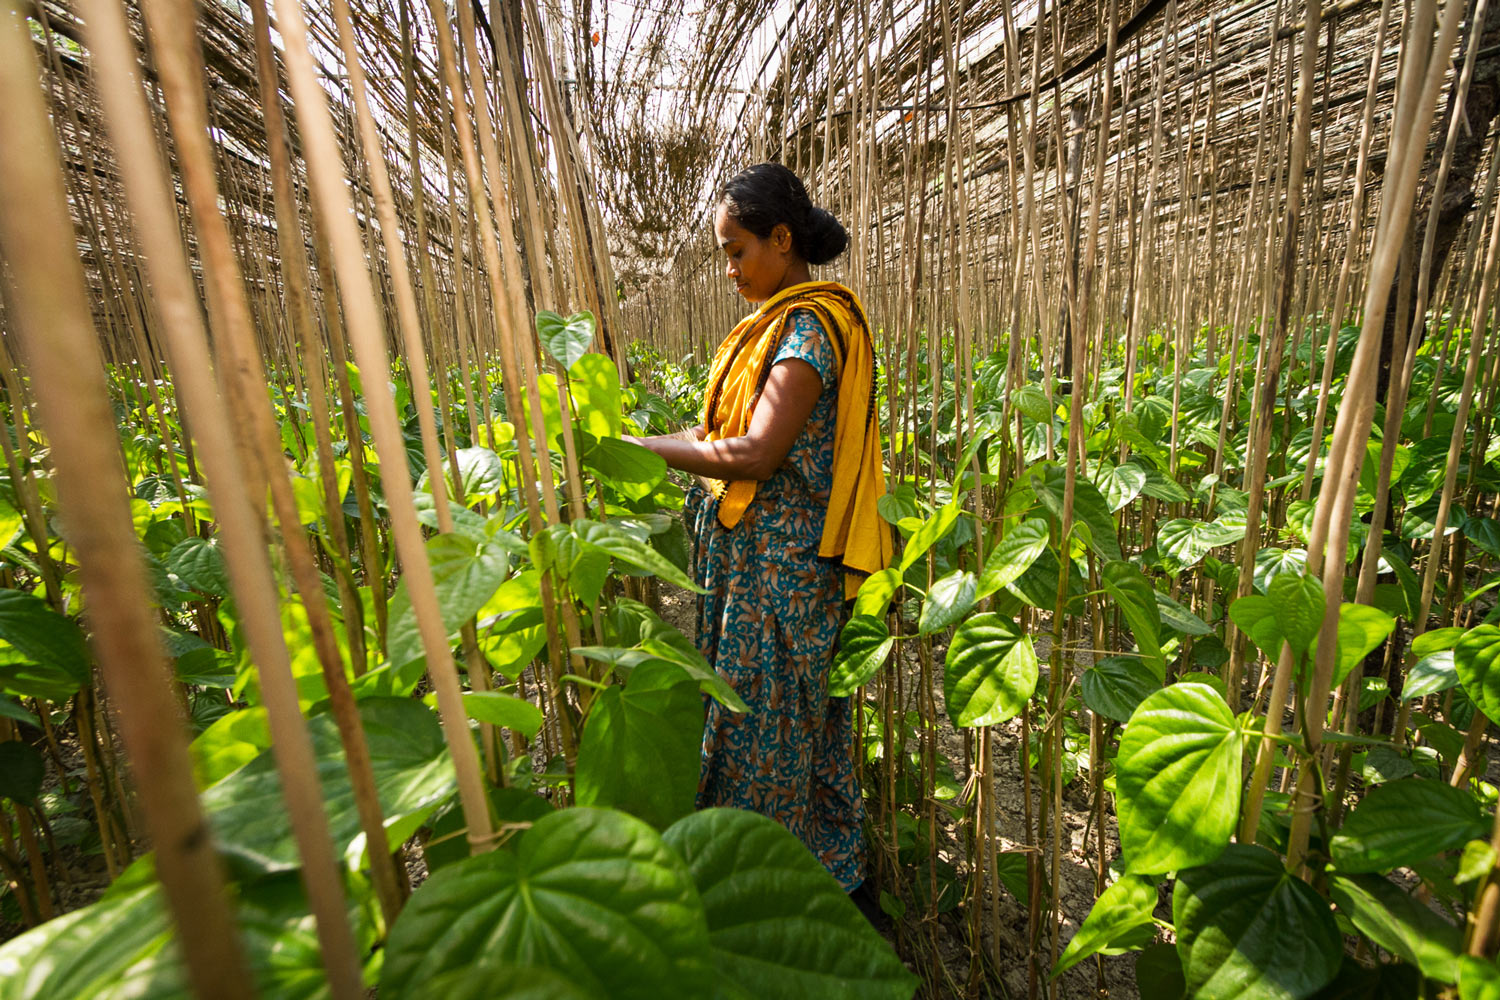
704, 282, 894, 597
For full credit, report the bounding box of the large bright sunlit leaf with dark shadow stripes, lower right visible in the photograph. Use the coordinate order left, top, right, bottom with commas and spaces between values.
1115, 682, 1244, 876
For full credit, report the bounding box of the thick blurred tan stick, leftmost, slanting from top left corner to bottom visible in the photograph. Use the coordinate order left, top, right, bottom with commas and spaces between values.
0, 1, 255, 1000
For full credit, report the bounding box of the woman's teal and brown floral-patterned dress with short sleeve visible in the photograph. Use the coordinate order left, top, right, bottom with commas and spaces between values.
684, 309, 864, 889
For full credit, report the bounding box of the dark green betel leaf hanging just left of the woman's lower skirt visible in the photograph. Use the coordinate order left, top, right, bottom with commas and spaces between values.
575, 660, 704, 829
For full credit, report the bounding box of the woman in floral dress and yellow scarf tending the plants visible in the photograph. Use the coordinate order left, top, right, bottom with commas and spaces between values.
639, 163, 891, 891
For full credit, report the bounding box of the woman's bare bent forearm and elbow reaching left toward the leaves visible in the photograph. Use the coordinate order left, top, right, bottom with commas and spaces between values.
626, 358, 824, 480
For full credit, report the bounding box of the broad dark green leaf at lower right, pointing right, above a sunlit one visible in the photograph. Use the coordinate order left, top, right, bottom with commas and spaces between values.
1329, 778, 1490, 874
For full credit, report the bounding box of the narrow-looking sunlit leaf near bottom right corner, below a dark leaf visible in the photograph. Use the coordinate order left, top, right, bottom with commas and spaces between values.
1328, 874, 1464, 982
